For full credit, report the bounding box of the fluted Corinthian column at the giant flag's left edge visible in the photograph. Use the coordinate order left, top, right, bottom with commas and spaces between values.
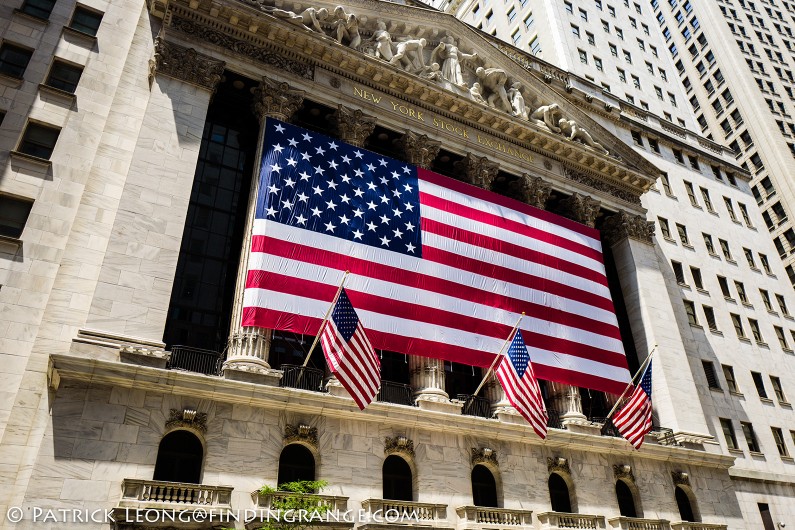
224, 77, 304, 385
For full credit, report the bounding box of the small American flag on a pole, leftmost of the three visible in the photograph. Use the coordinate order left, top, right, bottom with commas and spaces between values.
320, 289, 381, 409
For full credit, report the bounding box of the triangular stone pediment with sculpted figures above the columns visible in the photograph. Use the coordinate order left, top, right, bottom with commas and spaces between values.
155, 0, 660, 196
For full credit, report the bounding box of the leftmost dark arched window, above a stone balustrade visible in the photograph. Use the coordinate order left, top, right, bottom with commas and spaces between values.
152, 431, 204, 484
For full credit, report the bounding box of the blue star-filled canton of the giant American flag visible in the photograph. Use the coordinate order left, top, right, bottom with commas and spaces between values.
256, 119, 422, 257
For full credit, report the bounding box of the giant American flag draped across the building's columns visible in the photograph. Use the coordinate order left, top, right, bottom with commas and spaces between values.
242, 119, 630, 394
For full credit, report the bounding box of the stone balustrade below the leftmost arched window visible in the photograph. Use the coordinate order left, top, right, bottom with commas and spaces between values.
119, 478, 234, 508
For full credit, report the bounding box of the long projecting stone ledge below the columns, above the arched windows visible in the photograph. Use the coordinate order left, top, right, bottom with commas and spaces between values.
47, 354, 734, 469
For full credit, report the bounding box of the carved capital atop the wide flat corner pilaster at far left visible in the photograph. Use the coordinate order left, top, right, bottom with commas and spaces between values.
149, 36, 226, 92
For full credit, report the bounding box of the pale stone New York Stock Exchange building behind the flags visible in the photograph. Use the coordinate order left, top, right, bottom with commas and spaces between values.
0, 0, 795, 530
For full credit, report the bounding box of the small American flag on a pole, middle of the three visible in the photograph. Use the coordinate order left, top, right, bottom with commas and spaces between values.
497, 330, 549, 439
